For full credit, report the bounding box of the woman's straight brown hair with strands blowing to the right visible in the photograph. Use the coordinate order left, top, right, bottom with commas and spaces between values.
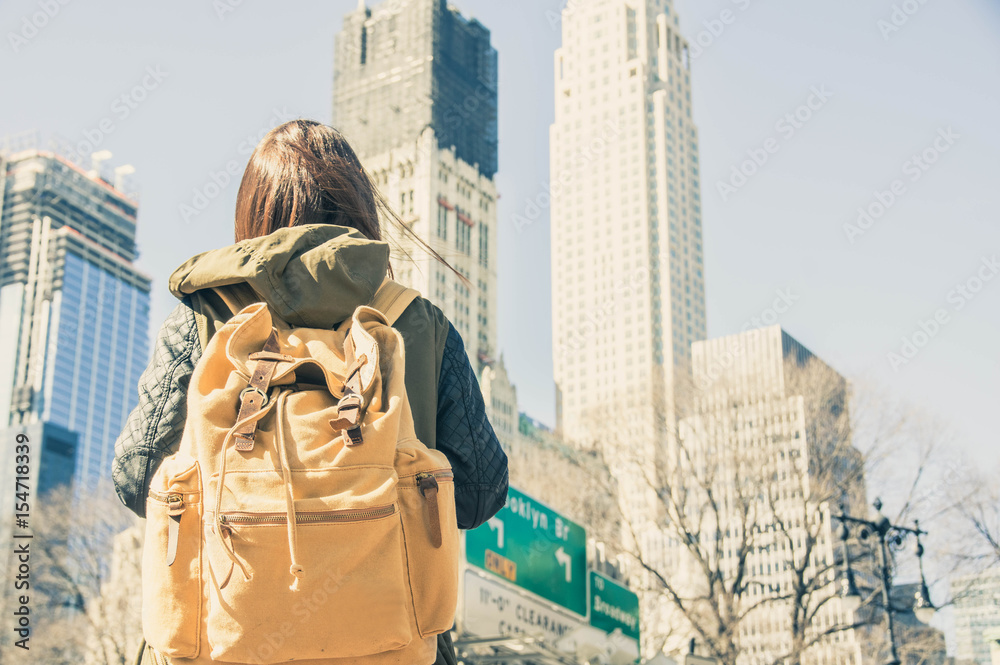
235, 119, 456, 281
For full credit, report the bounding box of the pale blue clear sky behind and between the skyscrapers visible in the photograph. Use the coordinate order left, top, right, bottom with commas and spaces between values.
0, 0, 1000, 472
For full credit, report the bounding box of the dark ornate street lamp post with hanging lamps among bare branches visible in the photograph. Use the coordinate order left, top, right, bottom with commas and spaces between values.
833, 499, 934, 665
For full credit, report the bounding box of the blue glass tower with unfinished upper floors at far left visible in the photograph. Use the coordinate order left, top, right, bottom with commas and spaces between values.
0, 150, 150, 491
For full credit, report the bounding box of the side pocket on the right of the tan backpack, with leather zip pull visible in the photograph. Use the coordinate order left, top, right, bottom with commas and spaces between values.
399, 469, 459, 637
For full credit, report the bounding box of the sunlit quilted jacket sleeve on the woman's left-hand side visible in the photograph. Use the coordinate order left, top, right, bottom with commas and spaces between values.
111, 301, 201, 517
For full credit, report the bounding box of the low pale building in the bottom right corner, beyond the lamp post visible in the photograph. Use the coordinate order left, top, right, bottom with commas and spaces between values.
951, 567, 1000, 665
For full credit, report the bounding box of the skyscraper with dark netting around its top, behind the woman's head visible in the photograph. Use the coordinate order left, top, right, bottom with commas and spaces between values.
333, 0, 497, 368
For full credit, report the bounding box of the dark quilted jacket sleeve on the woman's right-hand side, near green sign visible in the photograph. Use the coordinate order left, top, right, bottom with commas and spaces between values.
437, 325, 507, 529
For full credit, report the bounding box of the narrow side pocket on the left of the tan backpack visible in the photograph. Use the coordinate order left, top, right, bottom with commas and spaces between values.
142, 456, 202, 658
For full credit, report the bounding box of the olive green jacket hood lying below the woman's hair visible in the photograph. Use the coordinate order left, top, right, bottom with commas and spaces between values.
170, 224, 389, 328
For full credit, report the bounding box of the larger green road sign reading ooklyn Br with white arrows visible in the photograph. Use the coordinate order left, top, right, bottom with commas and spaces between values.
465, 487, 587, 616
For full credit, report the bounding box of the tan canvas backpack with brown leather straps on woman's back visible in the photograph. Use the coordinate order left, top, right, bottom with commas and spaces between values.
142, 280, 459, 665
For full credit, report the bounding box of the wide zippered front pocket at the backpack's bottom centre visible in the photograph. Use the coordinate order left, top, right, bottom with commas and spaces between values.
205, 503, 412, 664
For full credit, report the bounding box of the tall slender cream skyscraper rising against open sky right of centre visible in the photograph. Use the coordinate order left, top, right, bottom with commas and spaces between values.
549, 0, 705, 446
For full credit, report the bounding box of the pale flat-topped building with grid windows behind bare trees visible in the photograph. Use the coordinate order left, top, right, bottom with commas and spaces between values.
666, 326, 872, 665
